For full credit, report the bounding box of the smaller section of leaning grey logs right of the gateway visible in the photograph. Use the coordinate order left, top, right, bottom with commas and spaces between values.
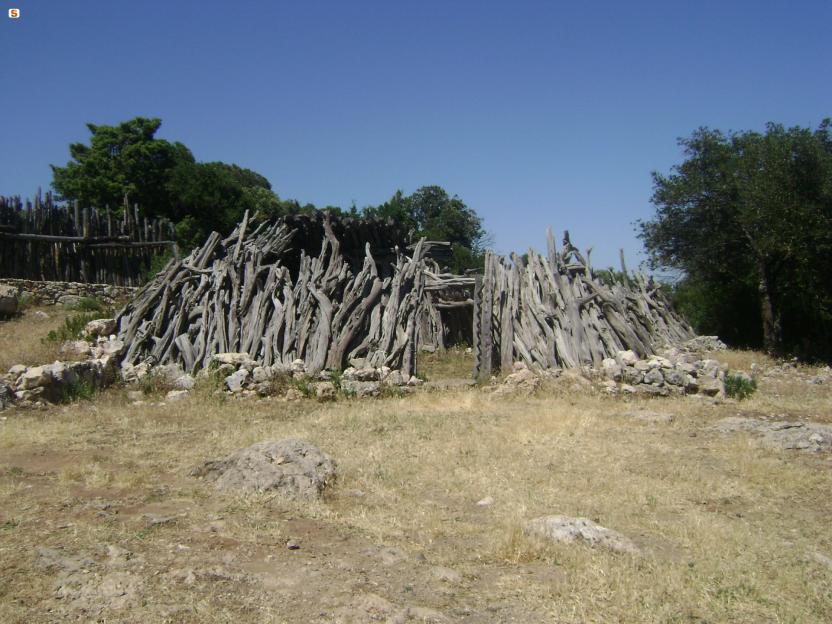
473, 229, 694, 378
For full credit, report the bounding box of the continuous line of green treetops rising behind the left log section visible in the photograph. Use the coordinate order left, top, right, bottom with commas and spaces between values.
52, 117, 486, 271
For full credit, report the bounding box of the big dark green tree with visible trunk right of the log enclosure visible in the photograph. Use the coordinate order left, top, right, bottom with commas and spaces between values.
639, 120, 832, 356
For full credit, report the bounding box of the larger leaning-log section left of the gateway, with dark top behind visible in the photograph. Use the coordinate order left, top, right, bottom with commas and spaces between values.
117, 213, 448, 375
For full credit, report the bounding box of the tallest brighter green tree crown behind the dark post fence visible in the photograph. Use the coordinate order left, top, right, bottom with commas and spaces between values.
51, 117, 194, 216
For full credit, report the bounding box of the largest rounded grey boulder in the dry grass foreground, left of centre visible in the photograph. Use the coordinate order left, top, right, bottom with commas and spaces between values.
191, 438, 336, 499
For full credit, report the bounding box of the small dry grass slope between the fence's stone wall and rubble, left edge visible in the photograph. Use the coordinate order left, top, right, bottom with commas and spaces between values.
0, 306, 77, 373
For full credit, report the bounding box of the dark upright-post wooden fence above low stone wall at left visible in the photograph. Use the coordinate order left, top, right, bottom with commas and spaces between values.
0, 191, 177, 286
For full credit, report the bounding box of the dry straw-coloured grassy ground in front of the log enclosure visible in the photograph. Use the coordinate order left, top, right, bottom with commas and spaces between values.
0, 310, 832, 623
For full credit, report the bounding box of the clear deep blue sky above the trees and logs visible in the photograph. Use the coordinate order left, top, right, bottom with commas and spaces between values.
0, 0, 832, 266
